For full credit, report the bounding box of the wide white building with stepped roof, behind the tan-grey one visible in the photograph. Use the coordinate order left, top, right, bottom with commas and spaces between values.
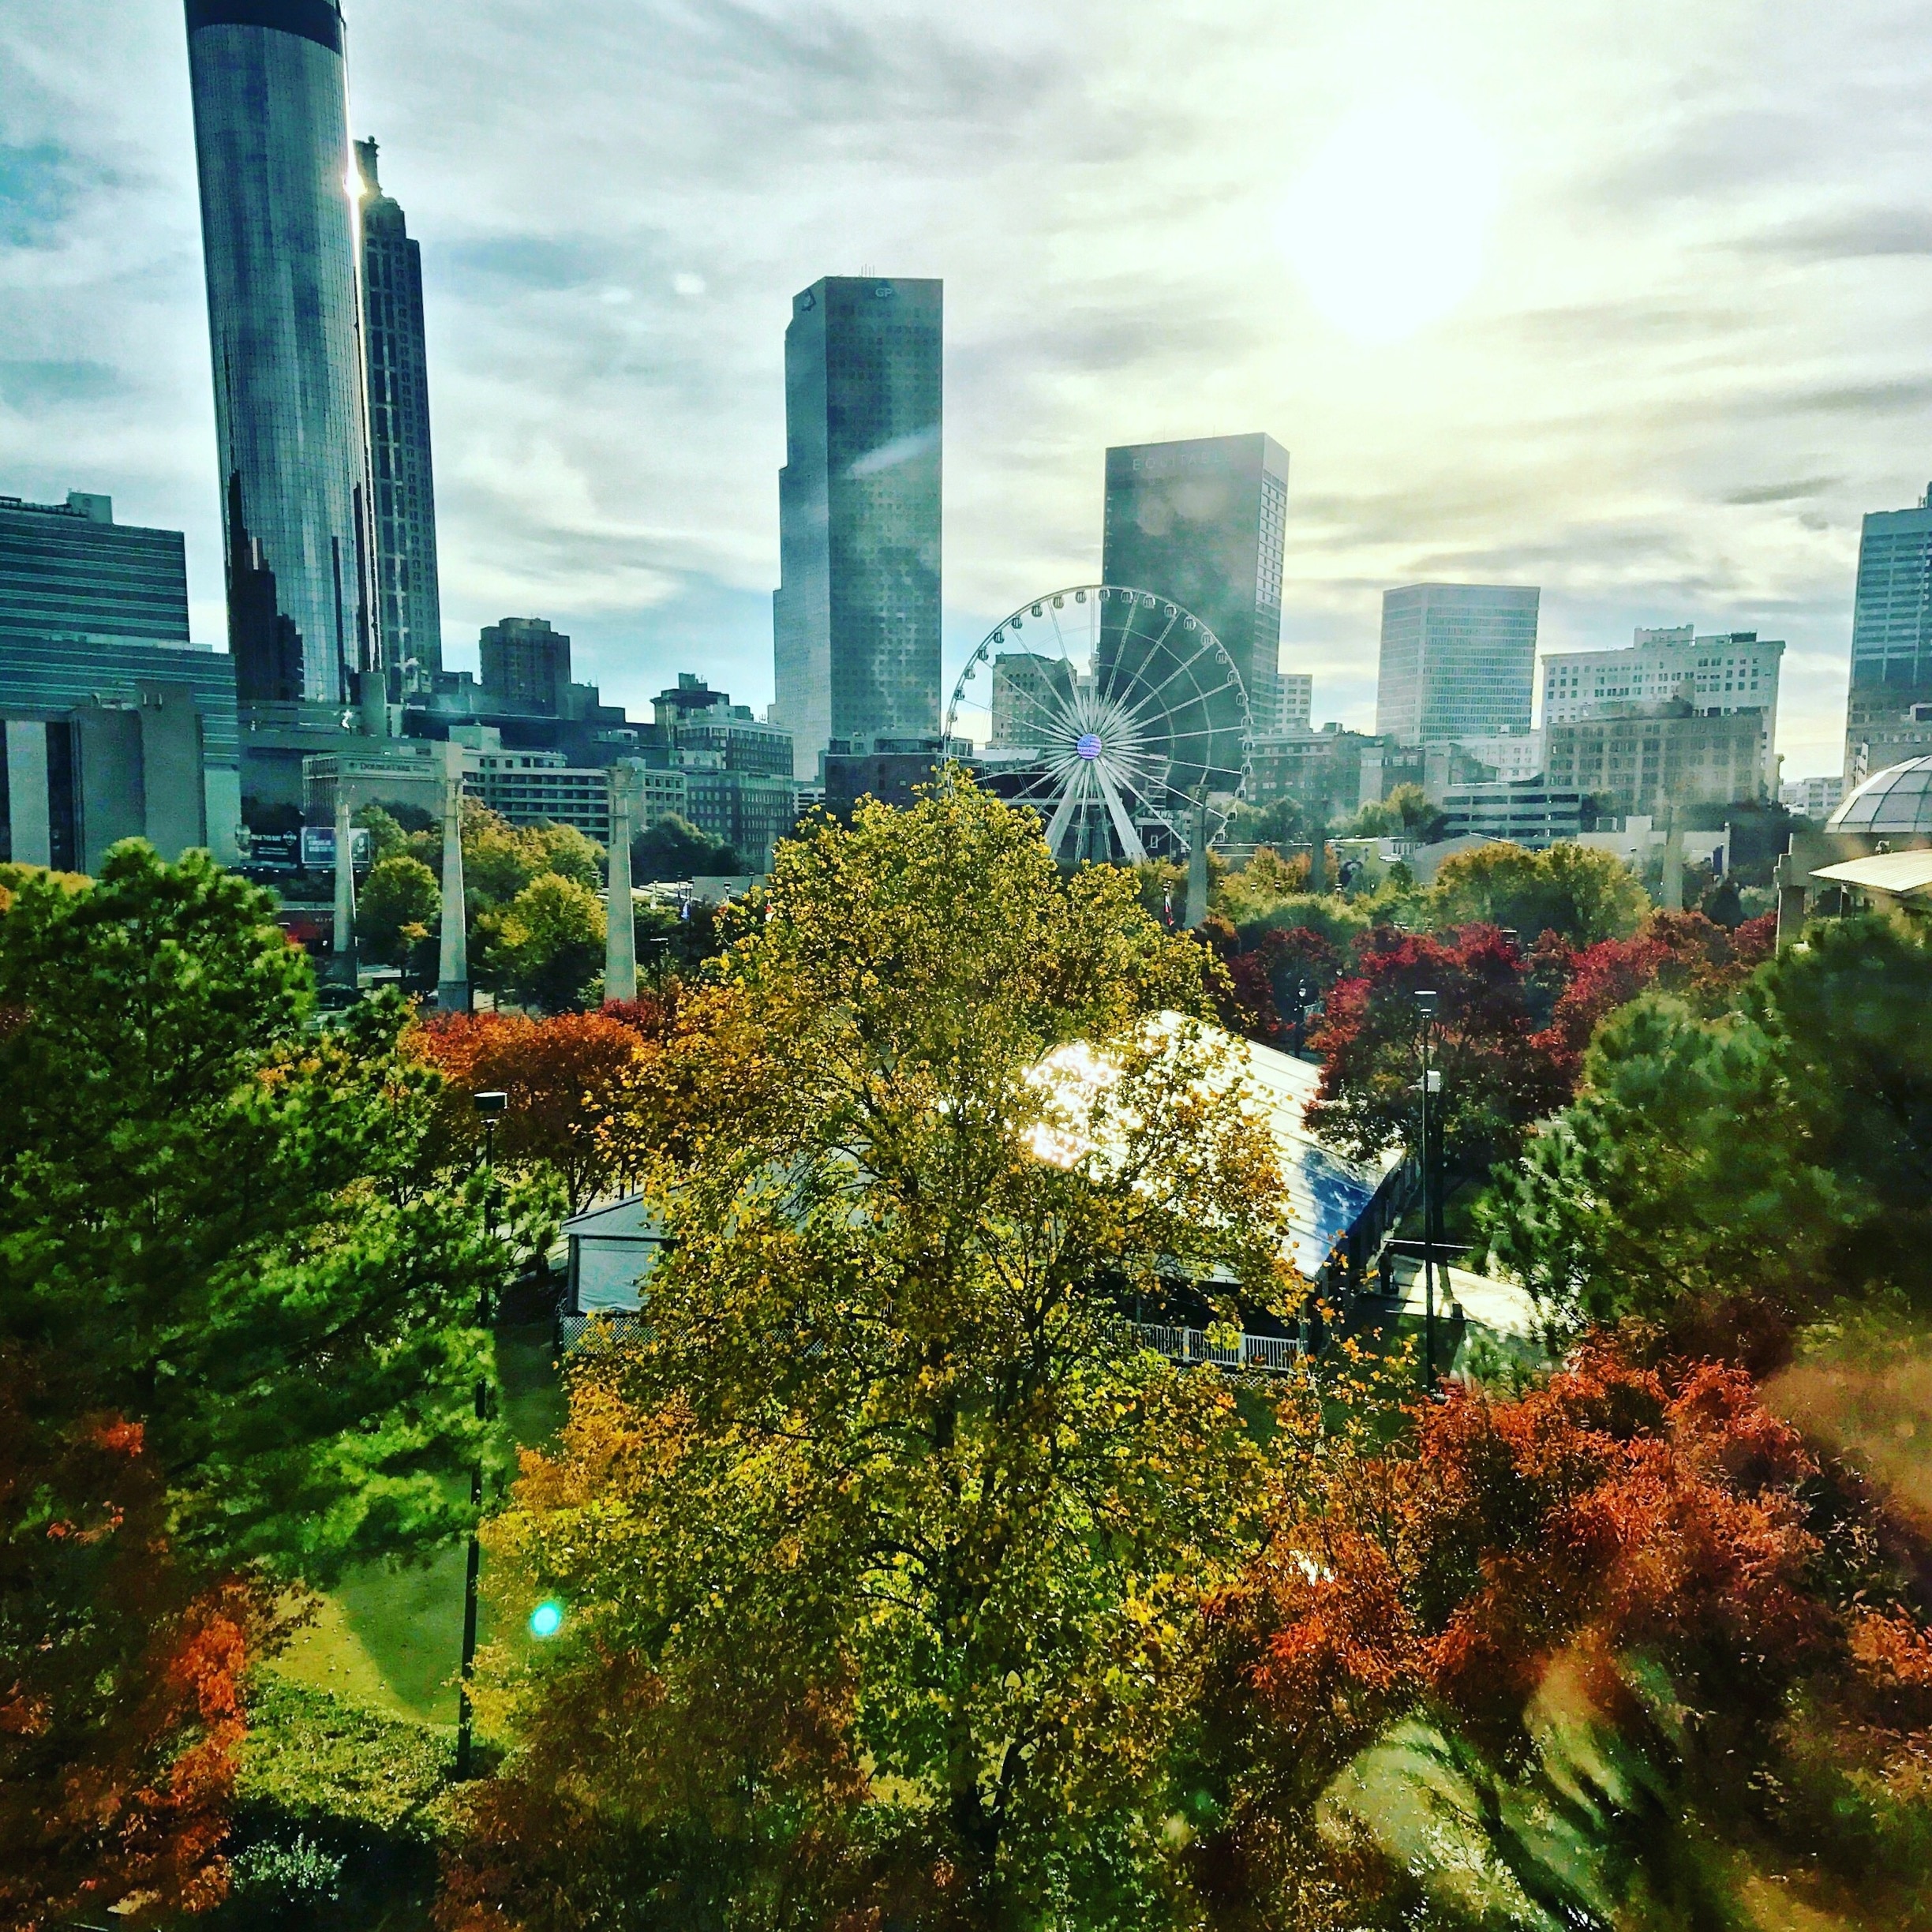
1544, 624, 1785, 786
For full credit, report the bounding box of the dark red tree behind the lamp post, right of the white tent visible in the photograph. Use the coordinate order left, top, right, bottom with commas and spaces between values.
1310, 926, 1569, 1167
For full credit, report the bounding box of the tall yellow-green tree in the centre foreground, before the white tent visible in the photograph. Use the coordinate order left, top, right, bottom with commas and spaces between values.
450, 784, 1285, 1928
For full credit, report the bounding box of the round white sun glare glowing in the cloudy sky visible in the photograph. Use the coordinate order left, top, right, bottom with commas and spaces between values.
1281, 95, 1500, 342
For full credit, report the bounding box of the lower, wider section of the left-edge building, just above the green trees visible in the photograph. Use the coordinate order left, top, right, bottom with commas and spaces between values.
0, 635, 242, 871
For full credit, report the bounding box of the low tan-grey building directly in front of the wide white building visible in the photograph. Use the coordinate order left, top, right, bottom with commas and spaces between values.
1544, 699, 1765, 823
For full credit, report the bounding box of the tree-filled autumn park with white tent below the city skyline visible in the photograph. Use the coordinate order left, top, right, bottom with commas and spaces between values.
0, 769, 1932, 1932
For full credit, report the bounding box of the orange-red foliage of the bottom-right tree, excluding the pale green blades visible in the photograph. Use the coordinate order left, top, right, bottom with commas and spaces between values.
1192, 1339, 1932, 1926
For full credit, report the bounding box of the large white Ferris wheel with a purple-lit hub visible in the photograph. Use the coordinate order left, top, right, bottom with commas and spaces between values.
947, 583, 1254, 863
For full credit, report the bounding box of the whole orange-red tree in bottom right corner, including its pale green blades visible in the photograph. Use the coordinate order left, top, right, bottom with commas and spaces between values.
1177, 1339, 1932, 1932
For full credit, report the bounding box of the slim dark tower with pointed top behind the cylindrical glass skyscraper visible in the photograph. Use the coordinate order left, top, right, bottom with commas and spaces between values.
355, 141, 443, 690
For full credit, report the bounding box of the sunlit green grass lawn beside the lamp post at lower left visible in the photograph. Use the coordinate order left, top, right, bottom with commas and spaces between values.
275, 1321, 564, 1731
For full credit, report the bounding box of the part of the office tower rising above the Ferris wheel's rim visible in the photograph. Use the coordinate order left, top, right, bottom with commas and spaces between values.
1101, 435, 1289, 734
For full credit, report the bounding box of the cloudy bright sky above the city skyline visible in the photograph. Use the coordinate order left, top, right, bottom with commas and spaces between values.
0, 0, 1932, 779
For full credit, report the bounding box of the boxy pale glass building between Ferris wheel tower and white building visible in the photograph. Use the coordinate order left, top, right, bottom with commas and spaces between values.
1376, 583, 1542, 743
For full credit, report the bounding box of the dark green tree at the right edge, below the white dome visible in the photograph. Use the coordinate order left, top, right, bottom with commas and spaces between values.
1482, 919, 1932, 1353
